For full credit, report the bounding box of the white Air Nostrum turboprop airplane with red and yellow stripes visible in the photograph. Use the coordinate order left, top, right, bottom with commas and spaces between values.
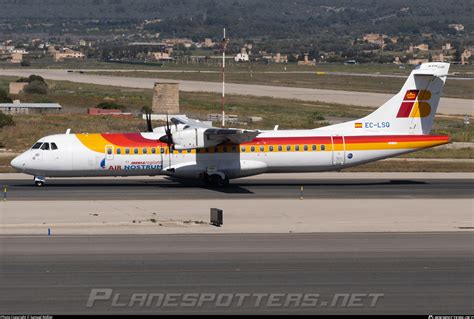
11, 63, 449, 186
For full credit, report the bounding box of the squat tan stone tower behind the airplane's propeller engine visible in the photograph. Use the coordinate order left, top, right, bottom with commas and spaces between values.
152, 82, 179, 114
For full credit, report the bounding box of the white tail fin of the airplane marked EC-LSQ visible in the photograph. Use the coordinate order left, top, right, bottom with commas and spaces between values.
324, 62, 449, 135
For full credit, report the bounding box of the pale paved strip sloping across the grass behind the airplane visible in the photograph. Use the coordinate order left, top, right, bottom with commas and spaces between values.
0, 69, 474, 115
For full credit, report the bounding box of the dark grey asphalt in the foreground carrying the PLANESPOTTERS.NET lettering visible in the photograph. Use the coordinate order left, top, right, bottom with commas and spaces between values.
0, 233, 474, 314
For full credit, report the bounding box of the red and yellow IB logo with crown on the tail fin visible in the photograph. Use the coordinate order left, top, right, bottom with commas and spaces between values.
397, 90, 431, 118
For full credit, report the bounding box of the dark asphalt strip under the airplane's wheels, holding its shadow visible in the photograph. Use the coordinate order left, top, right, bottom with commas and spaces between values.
0, 178, 474, 200
